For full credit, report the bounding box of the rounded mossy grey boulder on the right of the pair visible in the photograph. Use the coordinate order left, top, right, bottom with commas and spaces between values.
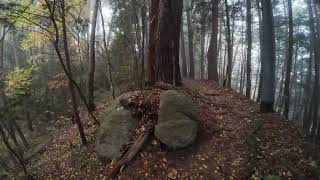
155, 90, 199, 149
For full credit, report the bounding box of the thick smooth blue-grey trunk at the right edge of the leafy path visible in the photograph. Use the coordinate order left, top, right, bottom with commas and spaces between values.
260, 0, 275, 113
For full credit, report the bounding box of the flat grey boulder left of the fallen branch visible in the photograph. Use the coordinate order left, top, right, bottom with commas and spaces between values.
95, 92, 137, 161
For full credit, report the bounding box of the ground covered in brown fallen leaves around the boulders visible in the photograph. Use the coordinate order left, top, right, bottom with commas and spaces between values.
21, 81, 319, 179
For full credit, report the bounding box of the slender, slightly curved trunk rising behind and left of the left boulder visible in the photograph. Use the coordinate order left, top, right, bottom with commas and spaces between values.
87, 0, 100, 111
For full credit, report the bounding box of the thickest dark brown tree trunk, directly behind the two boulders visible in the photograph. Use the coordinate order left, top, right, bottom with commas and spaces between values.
156, 0, 183, 85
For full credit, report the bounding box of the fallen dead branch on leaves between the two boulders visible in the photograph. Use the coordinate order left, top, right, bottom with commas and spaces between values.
111, 129, 151, 178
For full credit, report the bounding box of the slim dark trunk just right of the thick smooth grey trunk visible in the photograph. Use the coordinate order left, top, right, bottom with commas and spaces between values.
283, 0, 293, 119
